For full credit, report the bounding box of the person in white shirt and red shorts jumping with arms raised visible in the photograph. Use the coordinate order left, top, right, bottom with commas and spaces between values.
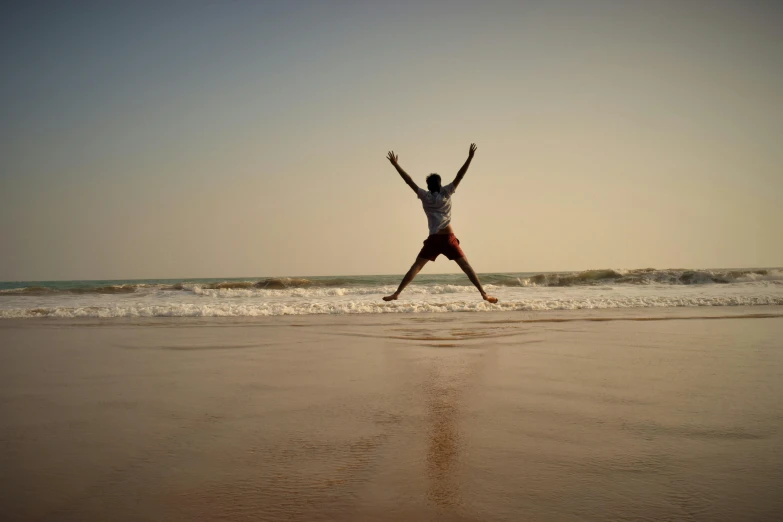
383, 143, 498, 303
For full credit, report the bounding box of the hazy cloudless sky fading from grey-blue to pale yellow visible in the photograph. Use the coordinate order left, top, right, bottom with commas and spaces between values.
0, 0, 783, 280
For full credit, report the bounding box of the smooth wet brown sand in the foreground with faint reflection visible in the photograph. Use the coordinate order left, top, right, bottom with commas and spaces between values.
0, 307, 783, 522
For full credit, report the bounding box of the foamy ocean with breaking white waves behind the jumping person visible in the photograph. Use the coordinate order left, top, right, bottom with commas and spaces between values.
0, 268, 783, 318
